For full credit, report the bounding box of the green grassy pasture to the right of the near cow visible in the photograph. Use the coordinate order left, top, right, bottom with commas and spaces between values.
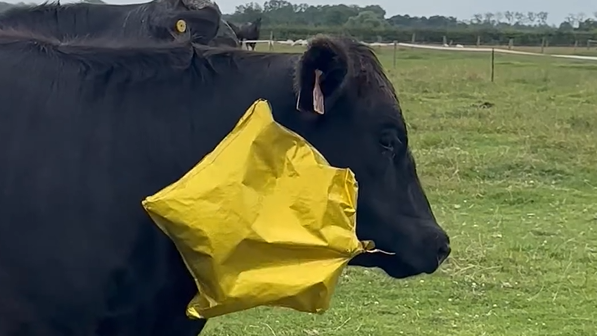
205, 48, 597, 336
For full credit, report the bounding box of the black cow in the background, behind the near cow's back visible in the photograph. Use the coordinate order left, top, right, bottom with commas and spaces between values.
0, 0, 240, 47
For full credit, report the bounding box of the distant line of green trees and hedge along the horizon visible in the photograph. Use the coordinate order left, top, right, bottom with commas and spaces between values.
0, 0, 597, 45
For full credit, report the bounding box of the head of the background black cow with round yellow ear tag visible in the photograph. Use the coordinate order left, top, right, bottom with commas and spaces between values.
150, 0, 222, 45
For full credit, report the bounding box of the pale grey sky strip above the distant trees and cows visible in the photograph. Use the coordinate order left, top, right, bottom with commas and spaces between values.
3, 0, 597, 24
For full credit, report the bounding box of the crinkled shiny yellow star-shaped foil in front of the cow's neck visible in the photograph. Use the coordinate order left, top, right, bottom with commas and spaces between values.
143, 100, 373, 318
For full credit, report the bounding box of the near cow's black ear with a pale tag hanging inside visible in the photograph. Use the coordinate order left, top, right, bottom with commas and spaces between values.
296, 36, 349, 114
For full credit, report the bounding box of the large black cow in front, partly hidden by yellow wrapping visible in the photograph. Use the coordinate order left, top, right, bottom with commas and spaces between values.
0, 27, 450, 336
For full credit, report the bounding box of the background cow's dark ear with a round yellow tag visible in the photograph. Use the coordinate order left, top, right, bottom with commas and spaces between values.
168, 6, 221, 45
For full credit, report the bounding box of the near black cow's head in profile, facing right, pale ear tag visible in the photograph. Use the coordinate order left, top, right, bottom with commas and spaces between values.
295, 36, 450, 278
